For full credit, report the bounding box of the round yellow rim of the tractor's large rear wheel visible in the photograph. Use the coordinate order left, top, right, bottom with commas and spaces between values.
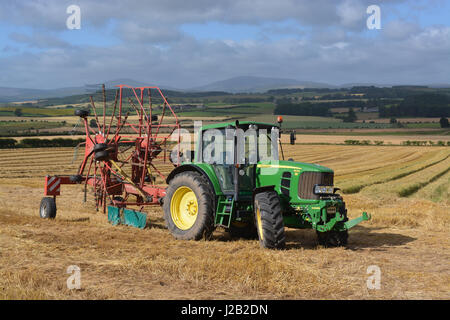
170, 186, 198, 230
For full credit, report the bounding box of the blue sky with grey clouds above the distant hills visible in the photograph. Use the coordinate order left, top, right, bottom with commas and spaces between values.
0, 0, 450, 88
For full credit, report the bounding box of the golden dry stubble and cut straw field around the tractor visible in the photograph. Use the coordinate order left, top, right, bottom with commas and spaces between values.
0, 146, 450, 299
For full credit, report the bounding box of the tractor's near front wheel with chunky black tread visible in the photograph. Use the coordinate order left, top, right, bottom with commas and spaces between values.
254, 191, 286, 249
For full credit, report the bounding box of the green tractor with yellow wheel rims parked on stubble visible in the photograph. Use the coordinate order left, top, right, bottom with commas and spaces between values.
163, 119, 370, 249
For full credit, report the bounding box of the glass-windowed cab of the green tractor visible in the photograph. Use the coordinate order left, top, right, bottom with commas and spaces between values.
194, 121, 279, 198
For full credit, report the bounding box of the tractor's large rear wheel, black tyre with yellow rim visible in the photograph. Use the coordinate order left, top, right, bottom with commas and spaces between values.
163, 171, 214, 240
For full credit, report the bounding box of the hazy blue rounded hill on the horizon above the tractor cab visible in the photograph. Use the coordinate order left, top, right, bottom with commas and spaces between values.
190, 76, 334, 93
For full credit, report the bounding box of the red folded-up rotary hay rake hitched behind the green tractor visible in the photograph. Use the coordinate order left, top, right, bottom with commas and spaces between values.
40, 85, 180, 225
